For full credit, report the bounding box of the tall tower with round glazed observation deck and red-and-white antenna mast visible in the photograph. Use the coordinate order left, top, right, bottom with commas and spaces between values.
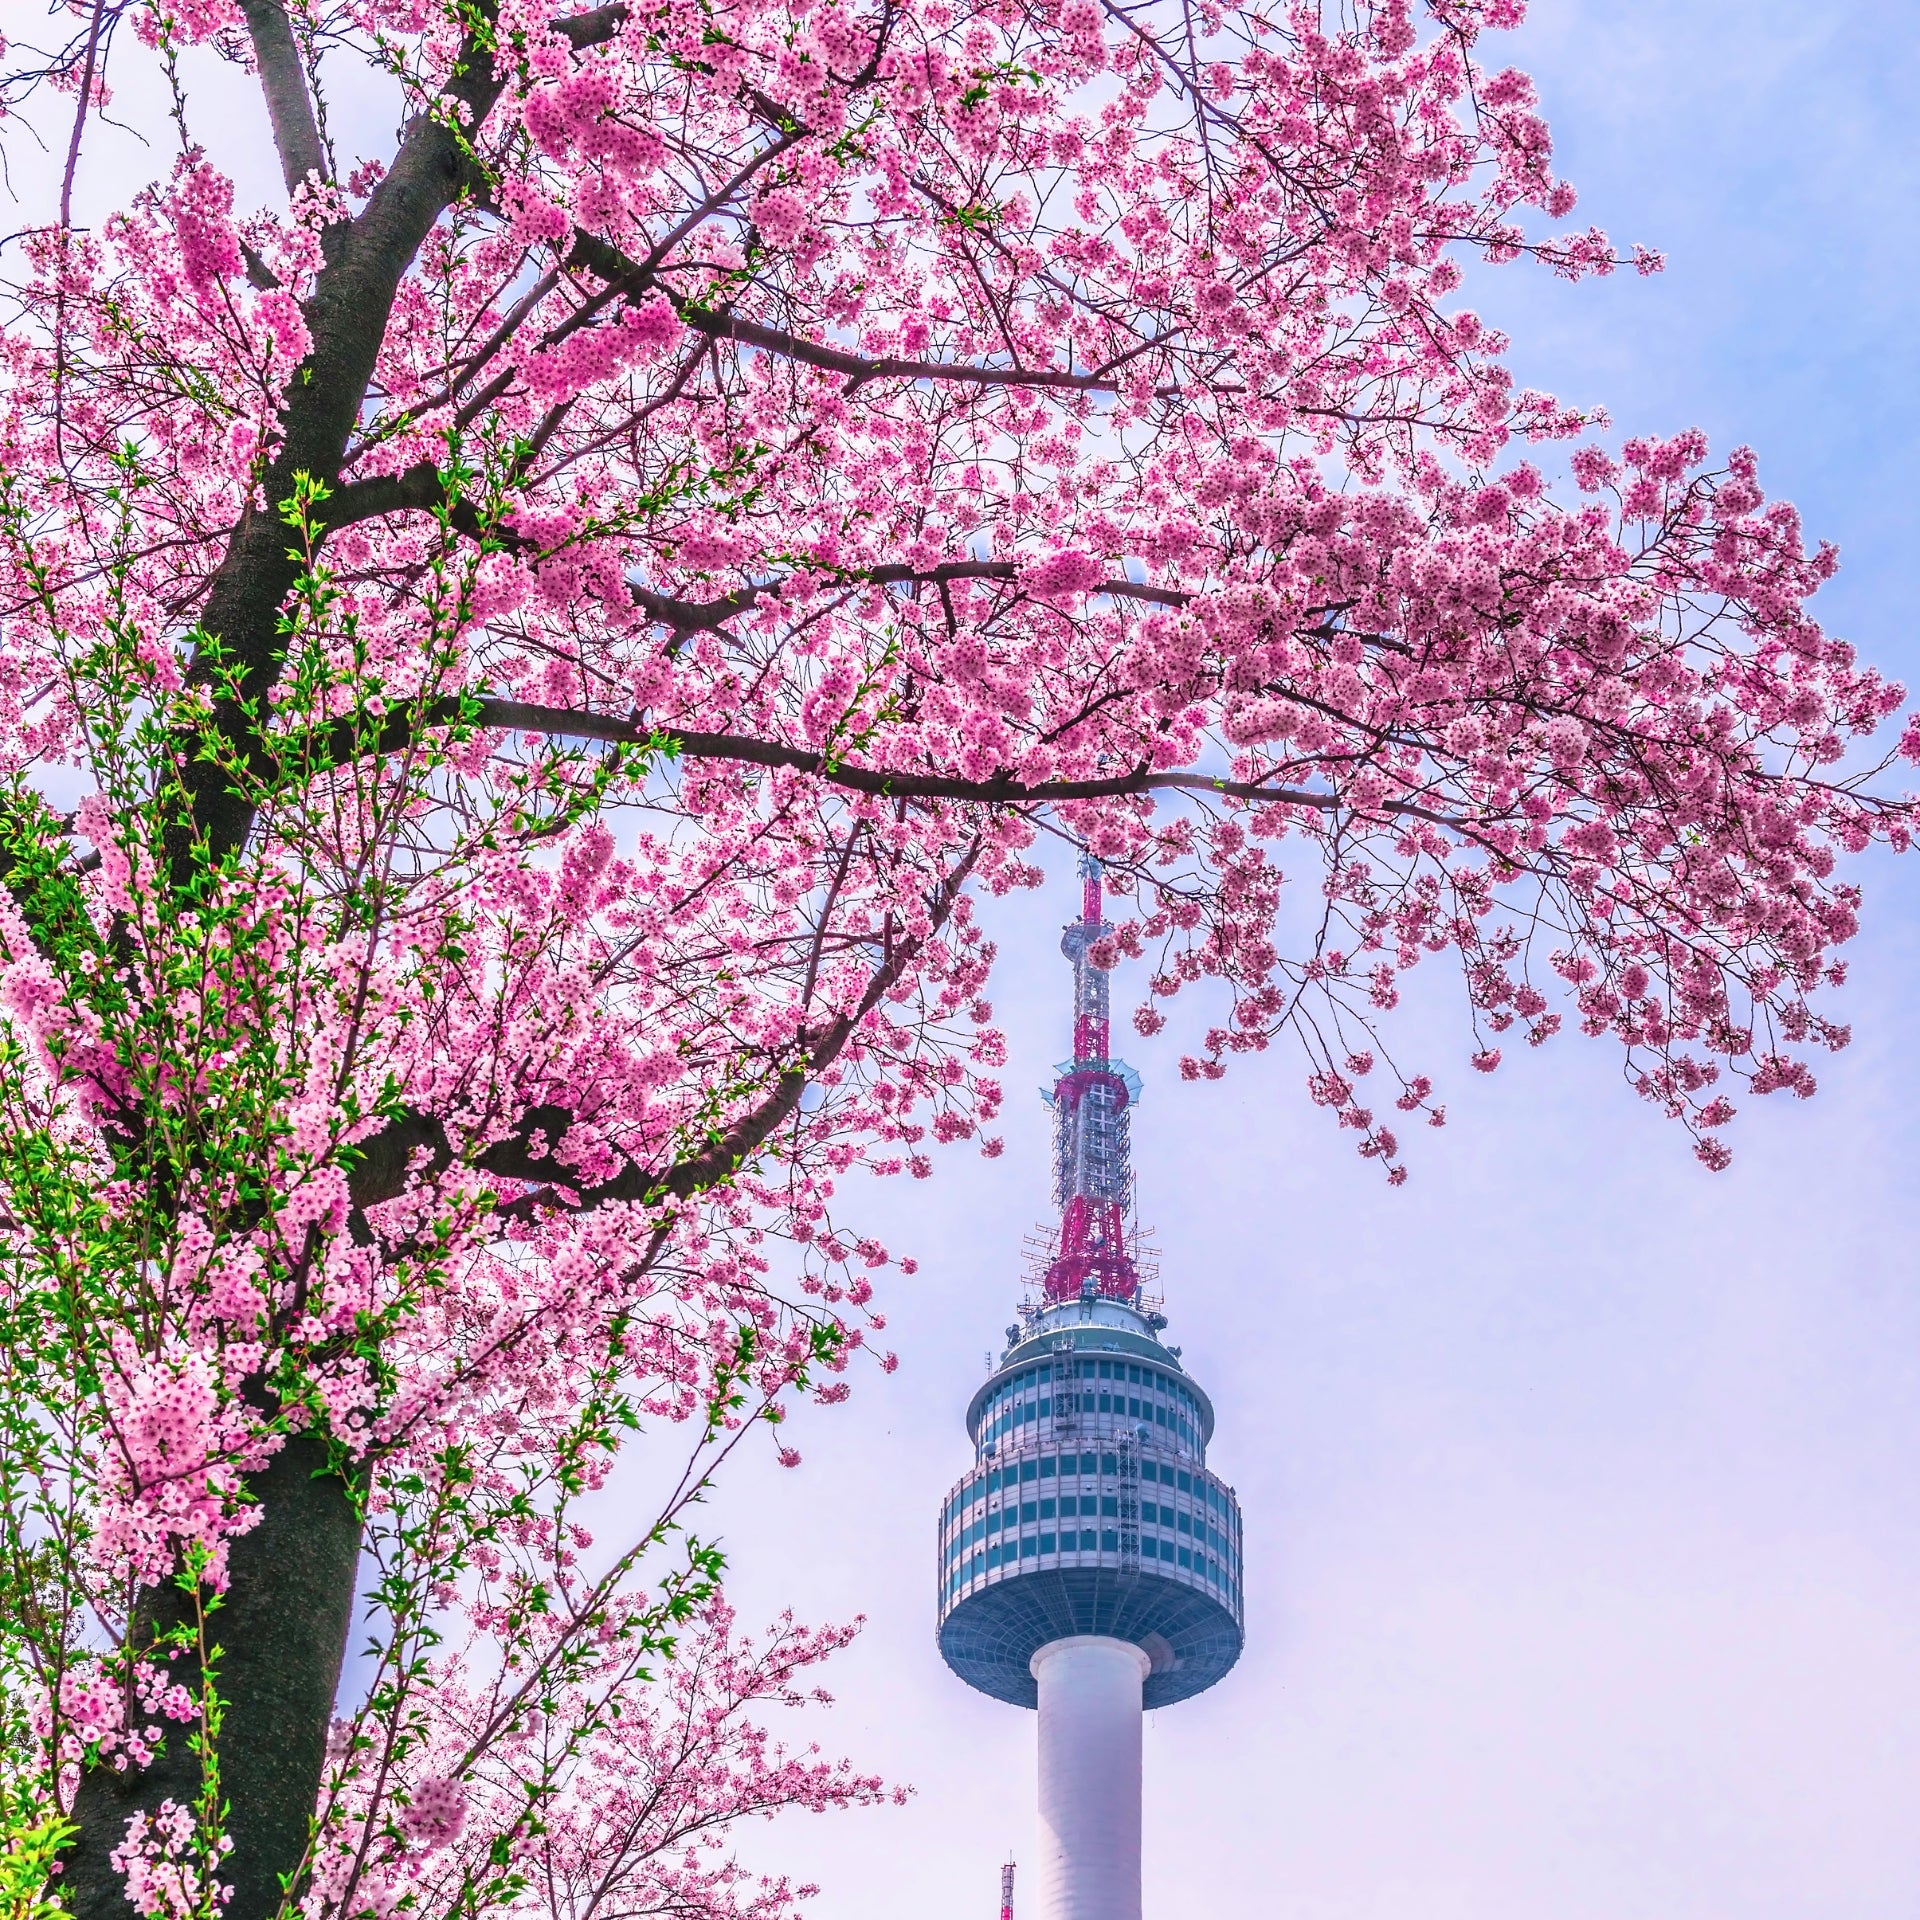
939, 858, 1242, 1920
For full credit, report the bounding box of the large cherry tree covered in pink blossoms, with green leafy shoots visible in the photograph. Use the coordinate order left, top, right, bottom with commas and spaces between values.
0, 0, 1920, 1920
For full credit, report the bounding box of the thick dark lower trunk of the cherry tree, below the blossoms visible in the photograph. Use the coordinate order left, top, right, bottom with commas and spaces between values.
56, 1434, 361, 1920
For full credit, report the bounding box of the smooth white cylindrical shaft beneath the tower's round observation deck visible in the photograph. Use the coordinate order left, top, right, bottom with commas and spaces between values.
1031, 1634, 1152, 1920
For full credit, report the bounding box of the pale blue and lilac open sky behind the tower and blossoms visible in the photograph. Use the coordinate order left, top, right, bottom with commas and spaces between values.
712, 0, 1920, 1920
